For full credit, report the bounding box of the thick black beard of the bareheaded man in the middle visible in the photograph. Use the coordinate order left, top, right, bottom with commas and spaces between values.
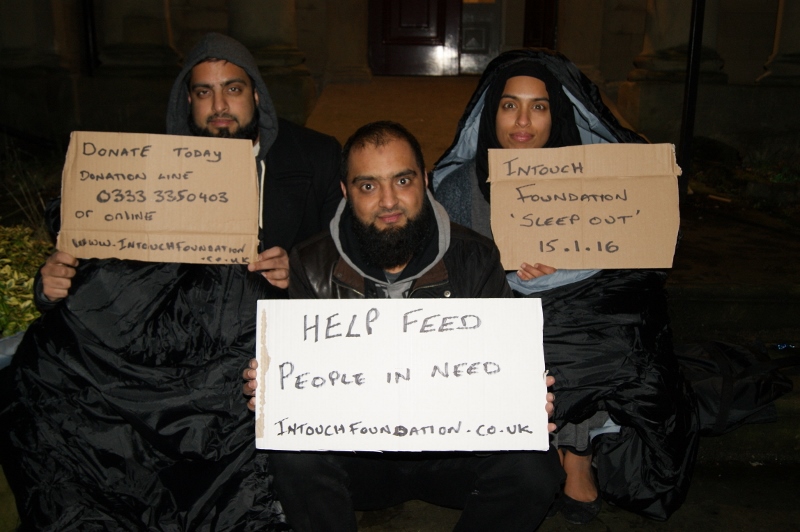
347, 195, 436, 270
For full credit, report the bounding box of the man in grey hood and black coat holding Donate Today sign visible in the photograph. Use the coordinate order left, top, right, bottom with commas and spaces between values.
36, 33, 342, 311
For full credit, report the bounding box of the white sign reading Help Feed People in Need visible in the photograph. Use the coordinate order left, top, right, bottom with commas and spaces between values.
256, 299, 549, 451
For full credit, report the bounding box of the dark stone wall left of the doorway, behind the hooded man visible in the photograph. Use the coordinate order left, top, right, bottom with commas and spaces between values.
0, 0, 328, 141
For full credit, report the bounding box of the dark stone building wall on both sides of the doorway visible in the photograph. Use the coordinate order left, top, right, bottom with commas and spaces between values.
0, 0, 800, 147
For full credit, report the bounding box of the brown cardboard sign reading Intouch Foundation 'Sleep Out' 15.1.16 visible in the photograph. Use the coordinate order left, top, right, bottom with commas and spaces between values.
489, 144, 680, 270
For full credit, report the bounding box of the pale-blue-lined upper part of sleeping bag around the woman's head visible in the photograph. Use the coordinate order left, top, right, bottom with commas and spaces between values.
430, 48, 646, 294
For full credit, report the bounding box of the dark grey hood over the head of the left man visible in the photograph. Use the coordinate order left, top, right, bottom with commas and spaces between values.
167, 33, 278, 157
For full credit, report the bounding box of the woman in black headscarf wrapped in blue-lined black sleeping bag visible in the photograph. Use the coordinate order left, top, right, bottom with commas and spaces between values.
431, 50, 697, 523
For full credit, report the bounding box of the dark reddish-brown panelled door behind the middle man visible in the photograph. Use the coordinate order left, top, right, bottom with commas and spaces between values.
369, 0, 461, 76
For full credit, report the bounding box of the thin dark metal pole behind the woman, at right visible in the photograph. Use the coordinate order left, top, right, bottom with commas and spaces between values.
678, 0, 706, 198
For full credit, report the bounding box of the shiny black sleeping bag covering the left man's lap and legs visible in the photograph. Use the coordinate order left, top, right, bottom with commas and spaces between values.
0, 260, 284, 531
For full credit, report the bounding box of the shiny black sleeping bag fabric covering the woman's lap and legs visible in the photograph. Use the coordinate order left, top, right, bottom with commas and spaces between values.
532, 270, 699, 520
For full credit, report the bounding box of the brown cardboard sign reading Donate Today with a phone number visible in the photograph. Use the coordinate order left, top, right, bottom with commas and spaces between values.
57, 131, 258, 264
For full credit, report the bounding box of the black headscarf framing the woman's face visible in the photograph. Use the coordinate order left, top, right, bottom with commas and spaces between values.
475, 61, 581, 201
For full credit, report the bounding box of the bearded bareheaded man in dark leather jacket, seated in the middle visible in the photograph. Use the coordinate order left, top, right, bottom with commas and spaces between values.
243, 122, 563, 532
